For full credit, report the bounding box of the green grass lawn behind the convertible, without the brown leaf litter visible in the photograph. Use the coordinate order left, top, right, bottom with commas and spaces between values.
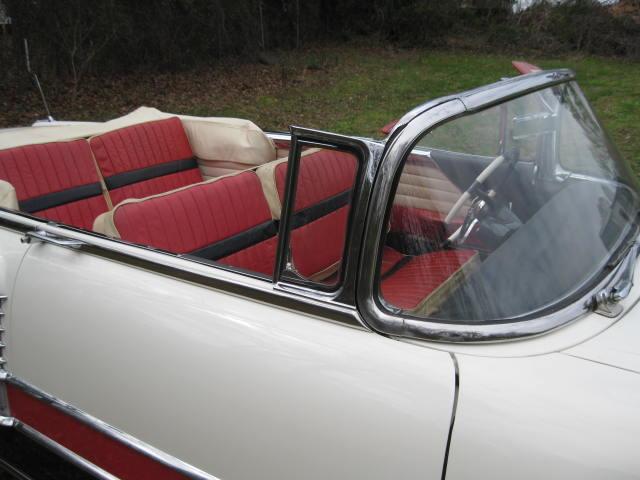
216, 51, 640, 172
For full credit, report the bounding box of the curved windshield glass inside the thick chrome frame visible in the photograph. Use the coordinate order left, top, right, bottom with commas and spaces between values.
378, 83, 638, 323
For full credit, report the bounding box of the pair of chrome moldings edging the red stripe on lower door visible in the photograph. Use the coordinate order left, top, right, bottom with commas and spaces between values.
0, 374, 216, 480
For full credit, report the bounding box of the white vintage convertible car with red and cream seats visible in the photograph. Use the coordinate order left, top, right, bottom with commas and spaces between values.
0, 66, 640, 480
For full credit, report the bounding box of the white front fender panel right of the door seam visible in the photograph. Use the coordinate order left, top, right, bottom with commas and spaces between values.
447, 353, 640, 480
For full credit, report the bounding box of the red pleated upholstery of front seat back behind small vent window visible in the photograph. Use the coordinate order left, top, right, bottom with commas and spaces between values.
275, 150, 358, 277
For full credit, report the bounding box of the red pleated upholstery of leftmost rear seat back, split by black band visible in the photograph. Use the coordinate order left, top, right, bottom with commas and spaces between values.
0, 140, 108, 230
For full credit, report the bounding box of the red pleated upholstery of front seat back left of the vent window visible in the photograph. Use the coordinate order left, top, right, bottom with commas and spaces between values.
113, 172, 277, 275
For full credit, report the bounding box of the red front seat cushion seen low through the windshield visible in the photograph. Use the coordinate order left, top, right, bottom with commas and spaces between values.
380, 250, 476, 310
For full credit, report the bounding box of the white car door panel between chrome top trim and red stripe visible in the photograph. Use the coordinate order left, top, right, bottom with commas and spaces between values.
8, 236, 455, 479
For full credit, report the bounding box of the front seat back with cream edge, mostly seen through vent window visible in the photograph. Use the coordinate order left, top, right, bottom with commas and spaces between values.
257, 149, 358, 281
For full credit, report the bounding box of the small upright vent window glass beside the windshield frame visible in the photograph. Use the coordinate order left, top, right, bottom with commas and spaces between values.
274, 142, 359, 288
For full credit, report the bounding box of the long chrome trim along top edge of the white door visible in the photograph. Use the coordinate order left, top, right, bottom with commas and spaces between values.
0, 208, 369, 330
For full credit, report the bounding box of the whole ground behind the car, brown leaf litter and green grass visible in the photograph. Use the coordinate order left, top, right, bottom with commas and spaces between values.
0, 45, 640, 173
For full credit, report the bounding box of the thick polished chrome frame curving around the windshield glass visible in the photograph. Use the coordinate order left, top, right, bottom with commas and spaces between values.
357, 70, 640, 343
